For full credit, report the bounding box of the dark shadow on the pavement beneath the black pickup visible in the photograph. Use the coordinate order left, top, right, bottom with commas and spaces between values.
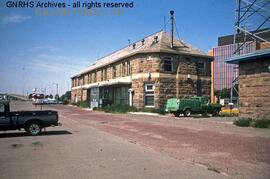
0, 130, 72, 138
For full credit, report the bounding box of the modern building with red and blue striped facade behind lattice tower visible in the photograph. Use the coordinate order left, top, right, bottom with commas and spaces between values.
213, 29, 270, 91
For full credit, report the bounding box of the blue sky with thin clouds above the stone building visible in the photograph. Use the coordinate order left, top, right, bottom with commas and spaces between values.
0, 0, 235, 94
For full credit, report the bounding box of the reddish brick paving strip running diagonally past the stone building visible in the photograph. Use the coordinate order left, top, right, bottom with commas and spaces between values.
2, 100, 270, 178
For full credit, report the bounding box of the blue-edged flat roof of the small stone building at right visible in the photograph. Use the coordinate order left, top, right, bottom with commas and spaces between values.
226, 48, 270, 64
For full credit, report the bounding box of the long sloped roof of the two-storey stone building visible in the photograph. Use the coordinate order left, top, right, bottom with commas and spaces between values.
72, 31, 211, 78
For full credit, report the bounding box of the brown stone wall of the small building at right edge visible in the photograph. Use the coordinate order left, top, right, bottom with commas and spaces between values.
239, 59, 270, 119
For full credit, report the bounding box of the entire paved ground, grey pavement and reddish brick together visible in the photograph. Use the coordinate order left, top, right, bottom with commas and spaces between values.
0, 102, 270, 178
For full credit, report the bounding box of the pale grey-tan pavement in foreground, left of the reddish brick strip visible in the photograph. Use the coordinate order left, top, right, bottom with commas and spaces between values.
0, 101, 228, 179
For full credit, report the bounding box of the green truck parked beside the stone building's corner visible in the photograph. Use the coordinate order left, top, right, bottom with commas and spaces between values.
166, 96, 222, 117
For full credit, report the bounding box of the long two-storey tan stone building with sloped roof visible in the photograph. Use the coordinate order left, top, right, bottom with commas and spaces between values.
71, 31, 212, 108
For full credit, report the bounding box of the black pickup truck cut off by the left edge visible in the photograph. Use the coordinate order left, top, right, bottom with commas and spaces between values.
0, 101, 60, 135
